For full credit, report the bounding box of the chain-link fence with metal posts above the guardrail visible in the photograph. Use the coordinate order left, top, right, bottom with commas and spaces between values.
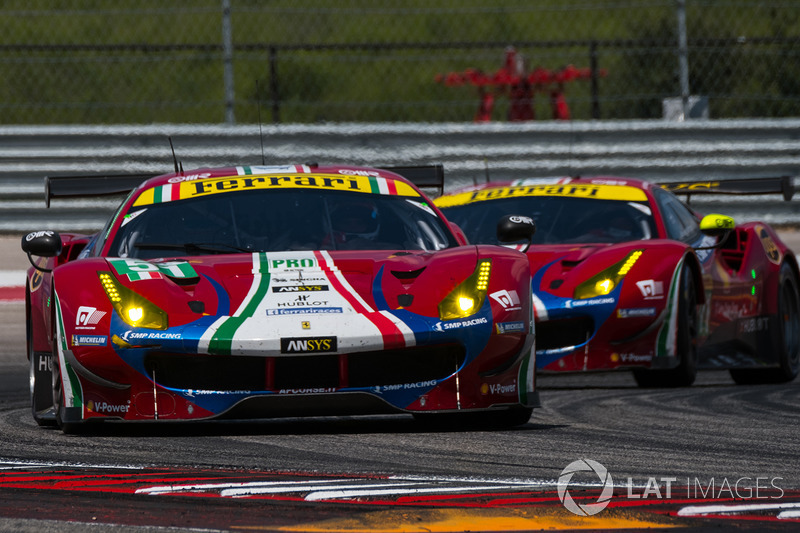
0, 0, 800, 124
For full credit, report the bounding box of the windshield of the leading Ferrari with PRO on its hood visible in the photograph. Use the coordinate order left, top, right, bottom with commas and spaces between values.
108, 189, 456, 259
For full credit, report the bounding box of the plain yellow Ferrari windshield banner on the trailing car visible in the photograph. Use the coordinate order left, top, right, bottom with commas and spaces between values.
434, 183, 647, 208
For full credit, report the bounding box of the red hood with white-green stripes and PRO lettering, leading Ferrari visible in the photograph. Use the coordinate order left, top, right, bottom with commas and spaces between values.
98, 247, 478, 324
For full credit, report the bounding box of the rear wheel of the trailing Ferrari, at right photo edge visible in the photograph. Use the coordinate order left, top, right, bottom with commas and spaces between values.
730, 263, 800, 385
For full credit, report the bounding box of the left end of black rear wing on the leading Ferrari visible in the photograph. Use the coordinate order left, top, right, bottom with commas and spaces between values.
44, 174, 158, 207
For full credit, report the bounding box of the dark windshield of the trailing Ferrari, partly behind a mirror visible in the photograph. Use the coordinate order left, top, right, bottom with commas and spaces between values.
442, 196, 656, 244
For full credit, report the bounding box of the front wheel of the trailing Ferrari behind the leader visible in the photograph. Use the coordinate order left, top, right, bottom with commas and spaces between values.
633, 265, 698, 387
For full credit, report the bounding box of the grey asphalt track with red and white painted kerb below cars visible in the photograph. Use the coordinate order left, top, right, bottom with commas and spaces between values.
0, 233, 800, 532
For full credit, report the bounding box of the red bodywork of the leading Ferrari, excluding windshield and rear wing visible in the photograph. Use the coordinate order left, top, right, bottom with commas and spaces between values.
28, 166, 538, 423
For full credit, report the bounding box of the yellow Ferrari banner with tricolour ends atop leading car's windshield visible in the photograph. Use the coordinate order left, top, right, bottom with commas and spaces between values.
133, 173, 419, 207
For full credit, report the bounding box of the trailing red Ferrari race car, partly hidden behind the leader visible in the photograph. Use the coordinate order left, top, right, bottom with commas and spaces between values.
436, 177, 800, 386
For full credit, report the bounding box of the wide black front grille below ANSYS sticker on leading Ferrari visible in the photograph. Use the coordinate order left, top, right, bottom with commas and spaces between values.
145, 344, 466, 391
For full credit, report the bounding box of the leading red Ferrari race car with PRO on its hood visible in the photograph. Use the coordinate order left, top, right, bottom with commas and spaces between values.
22, 165, 538, 432
